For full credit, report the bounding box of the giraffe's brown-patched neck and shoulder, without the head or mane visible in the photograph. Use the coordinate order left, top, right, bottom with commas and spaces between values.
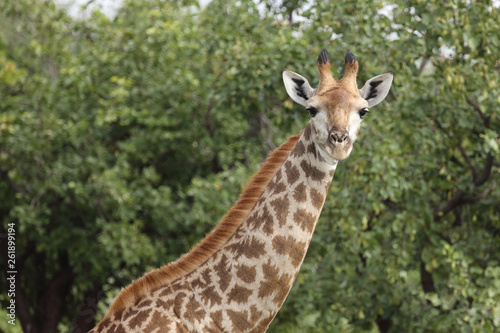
95, 125, 337, 332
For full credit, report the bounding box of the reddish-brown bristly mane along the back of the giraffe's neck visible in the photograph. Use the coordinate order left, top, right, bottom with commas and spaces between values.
106, 134, 301, 317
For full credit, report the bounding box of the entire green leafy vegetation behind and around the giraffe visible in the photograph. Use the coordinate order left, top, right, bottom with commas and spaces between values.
0, 0, 500, 333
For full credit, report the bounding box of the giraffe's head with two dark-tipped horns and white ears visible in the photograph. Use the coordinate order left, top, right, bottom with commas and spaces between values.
283, 49, 393, 161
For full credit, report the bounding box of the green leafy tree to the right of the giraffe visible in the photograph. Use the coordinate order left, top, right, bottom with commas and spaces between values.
275, 1, 500, 332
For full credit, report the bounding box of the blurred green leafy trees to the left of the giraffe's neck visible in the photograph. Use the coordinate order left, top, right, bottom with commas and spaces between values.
0, 0, 304, 332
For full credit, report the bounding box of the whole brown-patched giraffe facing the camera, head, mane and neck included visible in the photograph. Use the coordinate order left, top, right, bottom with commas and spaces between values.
90, 49, 393, 333
